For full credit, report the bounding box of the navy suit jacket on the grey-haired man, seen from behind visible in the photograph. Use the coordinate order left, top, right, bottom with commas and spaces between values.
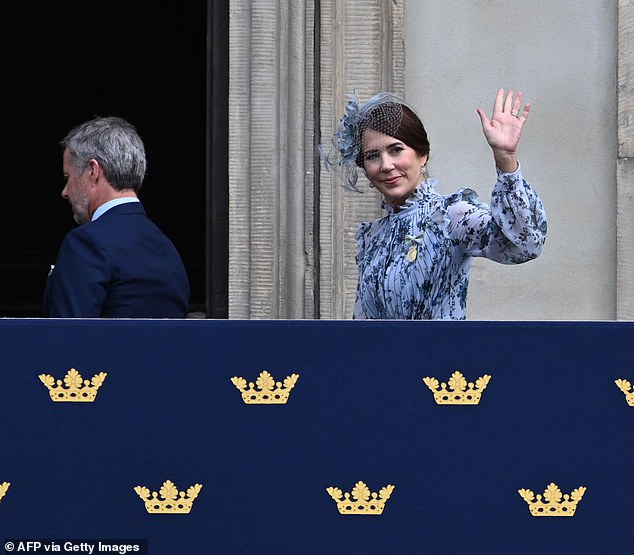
44, 202, 190, 318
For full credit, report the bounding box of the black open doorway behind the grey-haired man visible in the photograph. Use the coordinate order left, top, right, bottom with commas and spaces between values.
0, 0, 228, 317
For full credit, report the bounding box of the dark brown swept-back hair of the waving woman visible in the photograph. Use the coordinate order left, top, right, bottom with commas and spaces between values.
355, 102, 429, 168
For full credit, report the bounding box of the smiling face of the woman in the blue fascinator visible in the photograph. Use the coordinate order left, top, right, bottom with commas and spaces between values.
361, 129, 427, 208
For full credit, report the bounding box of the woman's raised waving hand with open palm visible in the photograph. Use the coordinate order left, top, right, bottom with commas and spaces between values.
476, 89, 531, 173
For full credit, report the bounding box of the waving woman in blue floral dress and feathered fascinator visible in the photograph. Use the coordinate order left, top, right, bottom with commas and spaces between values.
325, 89, 546, 320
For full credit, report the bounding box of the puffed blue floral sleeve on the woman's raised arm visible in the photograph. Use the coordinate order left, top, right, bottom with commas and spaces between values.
447, 167, 547, 264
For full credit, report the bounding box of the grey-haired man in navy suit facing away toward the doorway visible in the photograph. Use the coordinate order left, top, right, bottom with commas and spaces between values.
44, 117, 190, 318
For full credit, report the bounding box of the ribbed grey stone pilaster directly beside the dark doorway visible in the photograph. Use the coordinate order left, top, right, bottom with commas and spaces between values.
229, 0, 314, 318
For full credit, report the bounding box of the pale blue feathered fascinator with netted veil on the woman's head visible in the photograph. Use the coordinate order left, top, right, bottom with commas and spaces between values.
319, 92, 414, 192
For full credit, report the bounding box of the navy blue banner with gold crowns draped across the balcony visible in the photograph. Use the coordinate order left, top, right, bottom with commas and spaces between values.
0, 320, 634, 555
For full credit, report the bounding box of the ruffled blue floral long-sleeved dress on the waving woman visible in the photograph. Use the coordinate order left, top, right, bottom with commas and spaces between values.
354, 167, 546, 320
